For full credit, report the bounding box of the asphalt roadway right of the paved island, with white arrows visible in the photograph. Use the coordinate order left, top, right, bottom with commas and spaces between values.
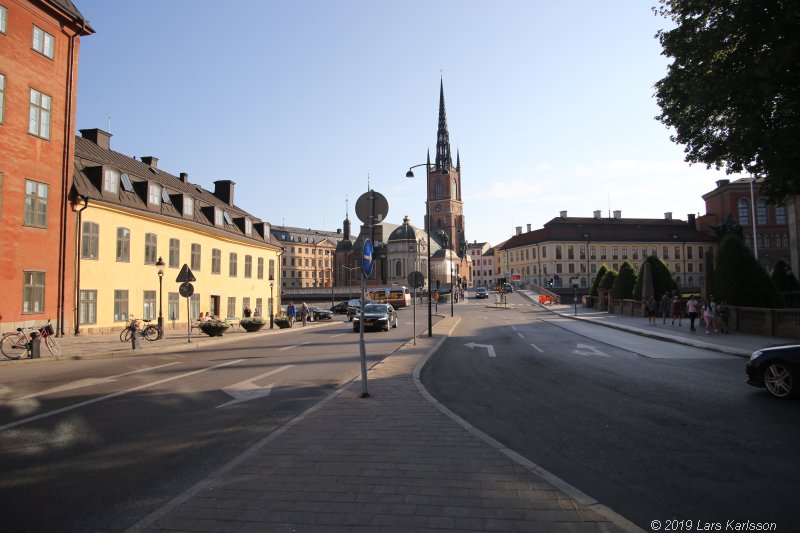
422, 294, 800, 531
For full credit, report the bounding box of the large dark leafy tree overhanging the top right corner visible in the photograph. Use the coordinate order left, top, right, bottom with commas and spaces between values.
654, 0, 800, 202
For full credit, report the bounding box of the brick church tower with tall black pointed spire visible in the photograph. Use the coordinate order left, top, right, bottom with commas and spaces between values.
425, 76, 466, 256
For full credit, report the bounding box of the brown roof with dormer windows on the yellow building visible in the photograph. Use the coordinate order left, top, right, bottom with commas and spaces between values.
71, 136, 280, 247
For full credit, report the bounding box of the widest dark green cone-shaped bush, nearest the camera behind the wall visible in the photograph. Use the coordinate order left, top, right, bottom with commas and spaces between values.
714, 235, 783, 308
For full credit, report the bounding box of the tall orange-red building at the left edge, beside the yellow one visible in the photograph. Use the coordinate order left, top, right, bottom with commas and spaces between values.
0, 0, 94, 332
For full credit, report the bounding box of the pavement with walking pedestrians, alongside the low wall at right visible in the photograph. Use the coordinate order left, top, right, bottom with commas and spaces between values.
517, 291, 800, 357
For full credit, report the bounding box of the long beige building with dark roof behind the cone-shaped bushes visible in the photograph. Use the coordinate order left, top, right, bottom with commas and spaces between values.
497, 211, 716, 290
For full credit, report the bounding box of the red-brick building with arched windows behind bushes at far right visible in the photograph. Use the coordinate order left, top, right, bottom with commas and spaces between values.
698, 178, 800, 275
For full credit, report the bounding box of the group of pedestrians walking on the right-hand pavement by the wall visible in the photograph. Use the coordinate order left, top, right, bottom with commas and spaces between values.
644, 294, 730, 335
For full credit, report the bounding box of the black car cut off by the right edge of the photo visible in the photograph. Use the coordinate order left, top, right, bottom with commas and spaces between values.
747, 344, 800, 398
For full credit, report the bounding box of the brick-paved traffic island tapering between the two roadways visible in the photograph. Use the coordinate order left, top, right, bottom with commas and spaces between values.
131, 318, 641, 533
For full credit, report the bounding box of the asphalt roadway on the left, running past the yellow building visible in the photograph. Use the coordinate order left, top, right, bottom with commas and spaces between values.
0, 310, 422, 532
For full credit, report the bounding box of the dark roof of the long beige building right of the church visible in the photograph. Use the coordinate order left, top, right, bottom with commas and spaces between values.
496, 217, 716, 250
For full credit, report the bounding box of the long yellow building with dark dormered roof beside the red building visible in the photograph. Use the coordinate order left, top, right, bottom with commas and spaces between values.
70, 129, 281, 333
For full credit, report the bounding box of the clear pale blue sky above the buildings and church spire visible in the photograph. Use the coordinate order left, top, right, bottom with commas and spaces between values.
75, 0, 726, 245
